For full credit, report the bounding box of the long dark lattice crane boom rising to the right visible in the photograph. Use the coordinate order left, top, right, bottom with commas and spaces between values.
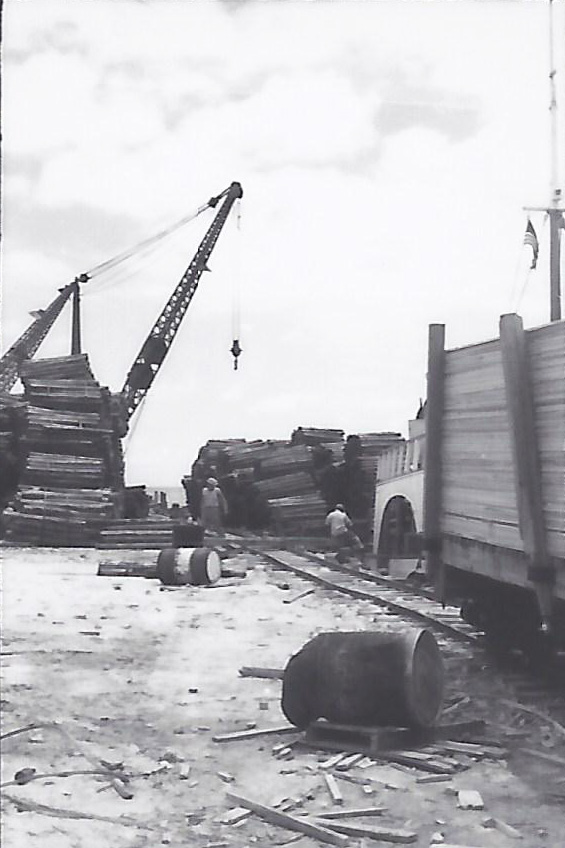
122, 182, 243, 418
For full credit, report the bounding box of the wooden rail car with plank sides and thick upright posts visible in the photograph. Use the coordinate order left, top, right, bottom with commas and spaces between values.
423, 314, 565, 646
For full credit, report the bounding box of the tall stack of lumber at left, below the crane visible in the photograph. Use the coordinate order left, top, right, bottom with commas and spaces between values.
4, 354, 125, 546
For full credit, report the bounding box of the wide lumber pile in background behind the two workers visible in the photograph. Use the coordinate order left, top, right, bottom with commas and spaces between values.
189, 427, 401, 536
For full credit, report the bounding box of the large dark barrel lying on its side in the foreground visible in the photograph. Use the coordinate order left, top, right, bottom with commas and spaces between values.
281, 629, 444, 728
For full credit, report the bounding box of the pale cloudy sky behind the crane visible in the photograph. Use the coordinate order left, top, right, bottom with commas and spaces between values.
2, 0, 565, 485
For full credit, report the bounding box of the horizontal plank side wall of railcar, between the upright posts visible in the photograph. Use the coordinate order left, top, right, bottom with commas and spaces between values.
440, 321, 565, 597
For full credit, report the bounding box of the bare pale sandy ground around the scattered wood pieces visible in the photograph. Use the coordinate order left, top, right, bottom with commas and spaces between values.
0, 548, 565, 848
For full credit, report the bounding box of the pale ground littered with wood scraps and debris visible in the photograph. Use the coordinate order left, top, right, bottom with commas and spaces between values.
1, 551, 565, 848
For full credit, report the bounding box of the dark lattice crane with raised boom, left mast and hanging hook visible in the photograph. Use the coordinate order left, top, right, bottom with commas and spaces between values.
0, 182, 243, 410
